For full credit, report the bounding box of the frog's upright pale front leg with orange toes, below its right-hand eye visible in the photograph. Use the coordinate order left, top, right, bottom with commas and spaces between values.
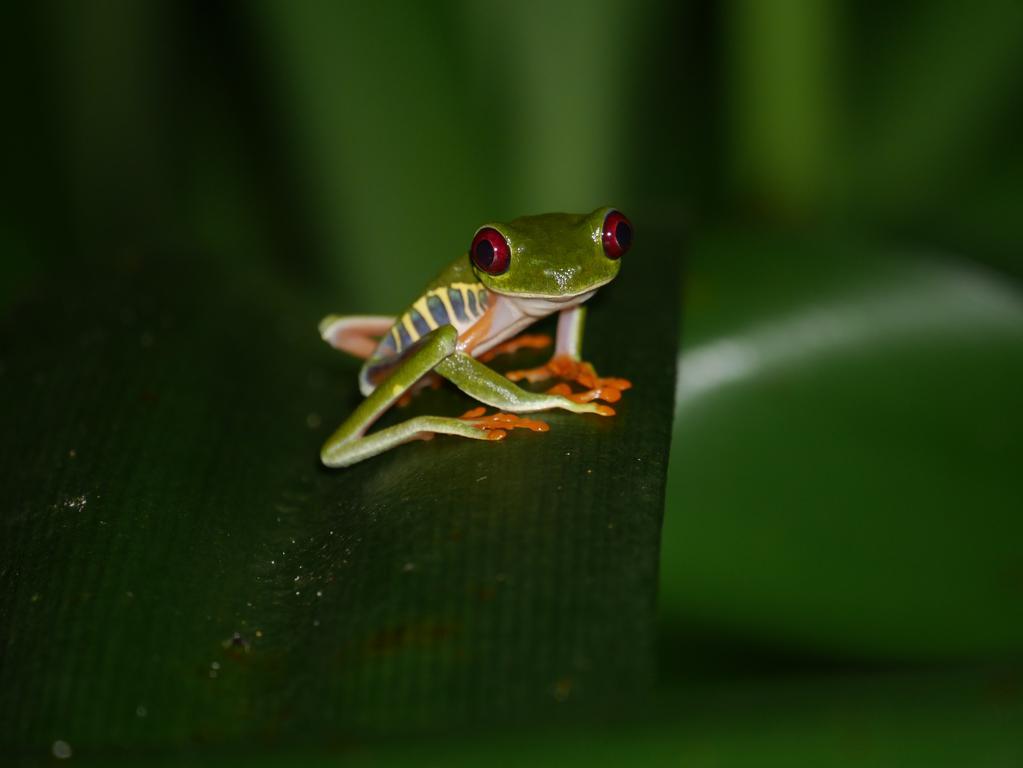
505, 306, 632, 403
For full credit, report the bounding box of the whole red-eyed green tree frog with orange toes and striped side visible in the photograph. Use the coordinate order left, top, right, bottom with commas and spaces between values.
319, 208, 632, 466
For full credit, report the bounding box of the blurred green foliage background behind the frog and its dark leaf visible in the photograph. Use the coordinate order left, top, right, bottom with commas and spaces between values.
0, 0, 1023, 765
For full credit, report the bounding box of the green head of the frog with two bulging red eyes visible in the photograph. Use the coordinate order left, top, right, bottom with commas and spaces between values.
469, 208, 632, 300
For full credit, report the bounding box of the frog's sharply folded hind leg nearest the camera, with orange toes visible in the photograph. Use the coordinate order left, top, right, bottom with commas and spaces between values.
320, 325, 546, 466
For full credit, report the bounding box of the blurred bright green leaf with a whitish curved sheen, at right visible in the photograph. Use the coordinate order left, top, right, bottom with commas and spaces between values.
661, 232, 1023, 661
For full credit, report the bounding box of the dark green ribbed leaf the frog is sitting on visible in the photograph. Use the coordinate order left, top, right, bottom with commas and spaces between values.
0, 228, 677, 757
